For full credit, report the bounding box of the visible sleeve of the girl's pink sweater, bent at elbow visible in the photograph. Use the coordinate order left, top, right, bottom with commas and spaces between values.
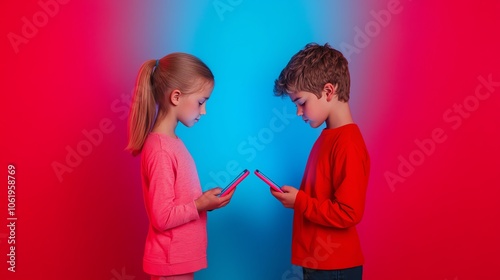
147, 152, 199, 231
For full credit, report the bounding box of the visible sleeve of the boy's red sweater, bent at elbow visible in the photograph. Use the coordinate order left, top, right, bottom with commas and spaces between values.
294, 145, 369, 228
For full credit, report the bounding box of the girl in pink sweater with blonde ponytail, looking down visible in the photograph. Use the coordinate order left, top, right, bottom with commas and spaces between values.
127, 53, 234, 280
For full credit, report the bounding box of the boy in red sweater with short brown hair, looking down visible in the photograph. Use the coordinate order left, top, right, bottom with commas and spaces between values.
271, 43, 370, 280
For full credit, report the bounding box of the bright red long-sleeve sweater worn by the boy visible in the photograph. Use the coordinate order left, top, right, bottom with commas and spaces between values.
292, 124, 370, 270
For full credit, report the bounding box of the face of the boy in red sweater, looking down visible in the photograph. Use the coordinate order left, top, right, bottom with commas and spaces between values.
288, 91, 330, 128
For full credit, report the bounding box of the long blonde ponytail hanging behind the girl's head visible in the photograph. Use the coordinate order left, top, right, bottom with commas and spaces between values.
125, 60, 156, 156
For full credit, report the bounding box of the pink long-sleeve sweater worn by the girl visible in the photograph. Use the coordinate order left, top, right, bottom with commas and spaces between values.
141, 133, 207, 276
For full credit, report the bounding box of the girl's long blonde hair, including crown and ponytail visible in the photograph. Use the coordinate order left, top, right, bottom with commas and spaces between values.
125, 53, 214, 156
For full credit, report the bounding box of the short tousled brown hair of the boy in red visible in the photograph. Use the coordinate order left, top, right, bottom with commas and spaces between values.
274, 43, 351, 102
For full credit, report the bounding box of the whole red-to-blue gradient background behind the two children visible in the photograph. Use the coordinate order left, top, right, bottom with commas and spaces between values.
0, 0, 500, 280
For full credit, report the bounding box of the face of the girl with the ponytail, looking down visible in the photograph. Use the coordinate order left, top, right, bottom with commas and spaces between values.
177, 82, 213, 127
